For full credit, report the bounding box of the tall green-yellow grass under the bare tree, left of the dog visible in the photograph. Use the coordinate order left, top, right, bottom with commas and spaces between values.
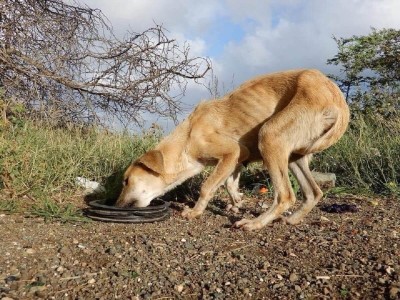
0, 121, 158, 206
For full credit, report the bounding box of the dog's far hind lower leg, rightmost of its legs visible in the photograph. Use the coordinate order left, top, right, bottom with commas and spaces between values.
284, 155, 323, 225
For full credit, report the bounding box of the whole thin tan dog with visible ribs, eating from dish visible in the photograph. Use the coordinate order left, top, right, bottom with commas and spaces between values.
117, 70, 349, 230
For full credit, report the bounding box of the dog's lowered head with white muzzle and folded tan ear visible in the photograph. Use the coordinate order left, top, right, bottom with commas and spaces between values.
116, 150, 167, 207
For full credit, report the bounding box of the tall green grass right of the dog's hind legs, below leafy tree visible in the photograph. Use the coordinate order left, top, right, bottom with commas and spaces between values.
313, 114, 400, 196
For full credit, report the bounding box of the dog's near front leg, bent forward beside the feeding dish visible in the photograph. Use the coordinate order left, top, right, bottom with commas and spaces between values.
182, 135, 249, 219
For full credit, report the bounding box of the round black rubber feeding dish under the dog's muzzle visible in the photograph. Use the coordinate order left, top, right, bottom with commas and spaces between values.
86, 199, 170, 223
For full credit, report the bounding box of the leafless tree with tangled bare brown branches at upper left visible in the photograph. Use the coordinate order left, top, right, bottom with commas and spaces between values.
0, 0, 211, 124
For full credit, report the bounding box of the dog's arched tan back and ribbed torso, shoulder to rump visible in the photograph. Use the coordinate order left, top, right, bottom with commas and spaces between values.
189, 70, 349, 160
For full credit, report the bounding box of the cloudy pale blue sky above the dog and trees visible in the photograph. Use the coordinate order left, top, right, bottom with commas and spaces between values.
79, 0, 400, 130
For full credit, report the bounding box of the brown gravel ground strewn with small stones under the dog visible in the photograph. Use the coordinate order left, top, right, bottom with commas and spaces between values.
0, 197, 400, 300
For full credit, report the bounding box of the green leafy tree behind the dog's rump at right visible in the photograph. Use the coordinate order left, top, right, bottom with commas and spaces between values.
328, 29, 400, 116
